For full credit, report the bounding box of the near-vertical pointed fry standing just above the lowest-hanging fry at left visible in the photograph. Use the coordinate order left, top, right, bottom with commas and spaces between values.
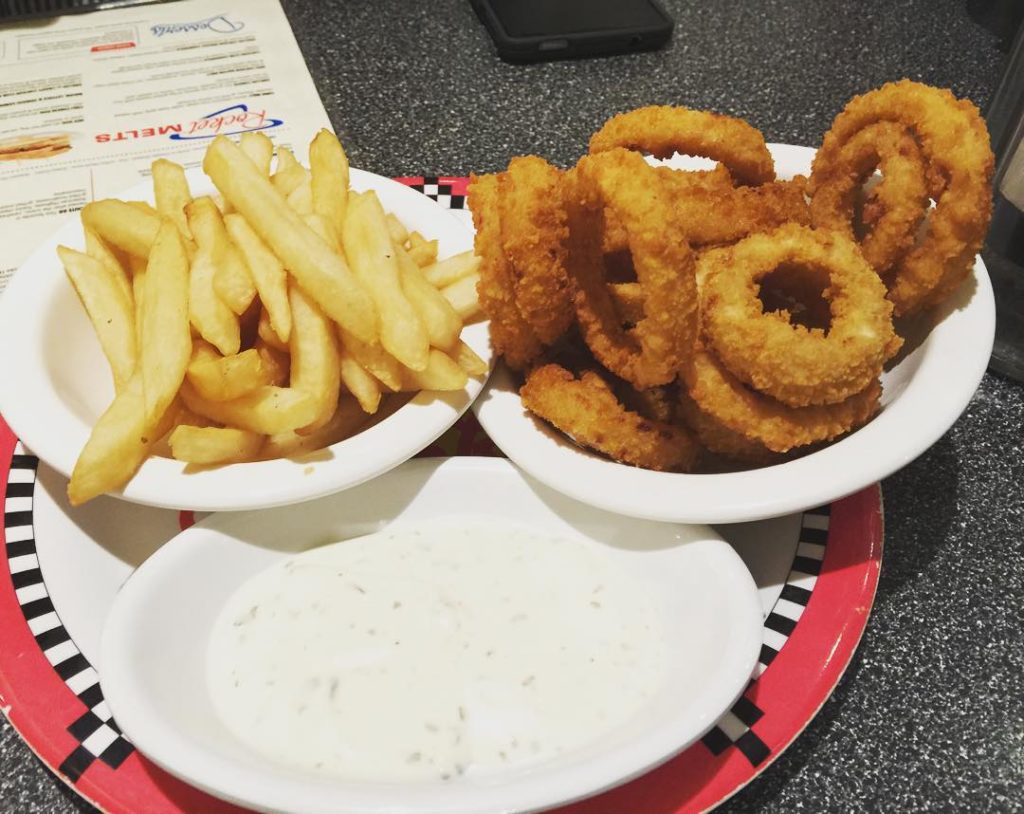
138, 220, 191, 424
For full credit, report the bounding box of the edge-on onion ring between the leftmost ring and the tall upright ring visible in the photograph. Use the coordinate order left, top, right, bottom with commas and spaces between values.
500, 156, 574, 345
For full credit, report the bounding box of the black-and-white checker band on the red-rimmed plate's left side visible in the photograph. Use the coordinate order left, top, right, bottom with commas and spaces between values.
4, 443, 134, 782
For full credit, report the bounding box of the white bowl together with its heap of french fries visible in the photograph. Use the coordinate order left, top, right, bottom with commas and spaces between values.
0, 131, 490, 511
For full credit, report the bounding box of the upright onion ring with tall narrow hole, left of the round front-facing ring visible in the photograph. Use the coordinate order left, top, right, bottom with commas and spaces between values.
564, 149, 697, 389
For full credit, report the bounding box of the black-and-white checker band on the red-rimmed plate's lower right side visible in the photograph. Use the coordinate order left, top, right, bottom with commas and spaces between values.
702, 506, 831, 766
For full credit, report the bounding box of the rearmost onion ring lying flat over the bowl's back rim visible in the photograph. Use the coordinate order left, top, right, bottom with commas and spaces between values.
590, 105, 775, 184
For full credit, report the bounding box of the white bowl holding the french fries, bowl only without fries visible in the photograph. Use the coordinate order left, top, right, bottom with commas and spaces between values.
0, 169, 490, 511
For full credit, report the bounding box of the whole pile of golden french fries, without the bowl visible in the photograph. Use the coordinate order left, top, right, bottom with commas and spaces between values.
57, 130, 486, 505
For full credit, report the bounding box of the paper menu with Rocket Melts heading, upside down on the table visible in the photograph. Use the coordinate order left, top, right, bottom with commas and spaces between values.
0, 0, 330, 291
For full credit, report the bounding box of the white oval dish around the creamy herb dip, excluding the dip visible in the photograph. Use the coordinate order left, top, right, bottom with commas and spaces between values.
100, 458, 762, 814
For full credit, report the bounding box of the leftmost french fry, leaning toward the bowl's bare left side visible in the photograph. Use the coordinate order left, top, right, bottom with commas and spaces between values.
57, 246, 137, 390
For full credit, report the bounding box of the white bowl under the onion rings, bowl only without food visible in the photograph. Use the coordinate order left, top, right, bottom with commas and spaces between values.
473, 144, 995, 523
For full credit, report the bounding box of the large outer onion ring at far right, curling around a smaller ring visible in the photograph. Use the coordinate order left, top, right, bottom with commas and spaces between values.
814, 80, 994, 316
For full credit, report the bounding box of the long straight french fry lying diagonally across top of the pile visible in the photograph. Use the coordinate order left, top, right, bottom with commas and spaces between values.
203, 136, 379, 342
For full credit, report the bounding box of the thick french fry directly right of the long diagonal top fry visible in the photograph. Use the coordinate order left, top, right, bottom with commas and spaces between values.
342, 192, 430, 371
